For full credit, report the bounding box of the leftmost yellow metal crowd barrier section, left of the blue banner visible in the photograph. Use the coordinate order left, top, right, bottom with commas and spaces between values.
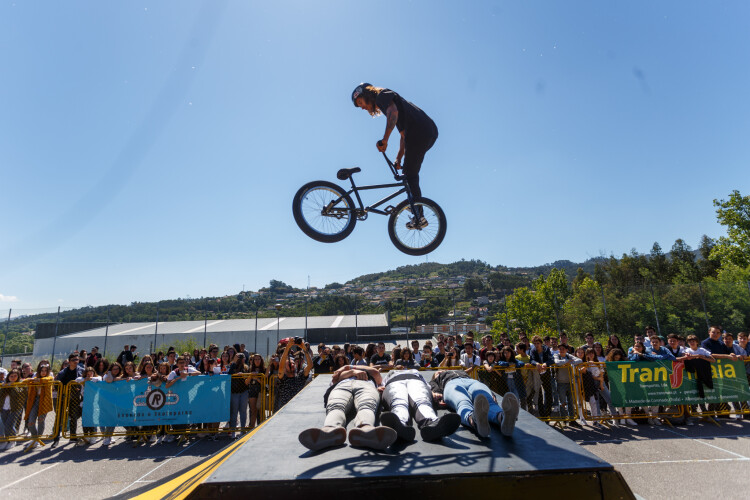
0, 379, 63, 445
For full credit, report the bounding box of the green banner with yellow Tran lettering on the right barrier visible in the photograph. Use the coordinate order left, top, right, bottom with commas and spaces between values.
607, 359, 750, 407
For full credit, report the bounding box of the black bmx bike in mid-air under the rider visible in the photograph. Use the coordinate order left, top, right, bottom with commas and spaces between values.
292, 144, 447, 255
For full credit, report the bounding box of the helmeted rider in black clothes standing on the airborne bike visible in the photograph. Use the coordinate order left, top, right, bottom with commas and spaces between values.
352, 83, 438, 229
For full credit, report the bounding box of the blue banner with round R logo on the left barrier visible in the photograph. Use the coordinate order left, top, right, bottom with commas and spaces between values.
83, 375, 231, 427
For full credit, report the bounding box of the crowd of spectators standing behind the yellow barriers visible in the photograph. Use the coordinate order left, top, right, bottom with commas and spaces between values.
0, 327, 750, 451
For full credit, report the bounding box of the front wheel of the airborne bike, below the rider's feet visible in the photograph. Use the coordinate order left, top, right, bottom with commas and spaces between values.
388, 198, 448, 255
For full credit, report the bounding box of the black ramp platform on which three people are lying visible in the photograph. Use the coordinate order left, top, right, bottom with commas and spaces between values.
193, 372, 630, 498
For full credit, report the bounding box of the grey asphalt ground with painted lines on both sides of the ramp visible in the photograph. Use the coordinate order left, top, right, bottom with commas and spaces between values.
0, 419, 750, 500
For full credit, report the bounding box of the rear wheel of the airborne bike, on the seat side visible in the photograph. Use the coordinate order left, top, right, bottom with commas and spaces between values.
292, 181, 357, 243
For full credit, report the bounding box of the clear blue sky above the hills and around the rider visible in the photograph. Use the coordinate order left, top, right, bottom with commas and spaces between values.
0, 0, 750, 314
